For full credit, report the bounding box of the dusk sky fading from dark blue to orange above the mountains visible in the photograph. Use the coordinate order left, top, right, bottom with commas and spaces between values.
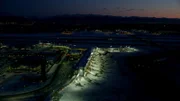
0, 0, 180, 18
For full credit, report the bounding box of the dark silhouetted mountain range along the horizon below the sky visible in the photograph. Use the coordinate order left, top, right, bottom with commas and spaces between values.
0, 13, 180, 24
